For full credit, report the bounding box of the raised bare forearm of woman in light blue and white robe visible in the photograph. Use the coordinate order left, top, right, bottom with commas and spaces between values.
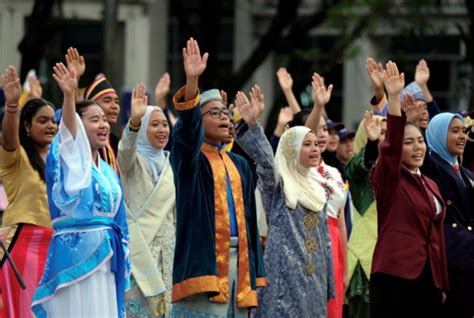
53, 63, 77, 138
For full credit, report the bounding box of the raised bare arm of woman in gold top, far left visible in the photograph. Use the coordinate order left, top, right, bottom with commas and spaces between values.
2, 65, 21, 151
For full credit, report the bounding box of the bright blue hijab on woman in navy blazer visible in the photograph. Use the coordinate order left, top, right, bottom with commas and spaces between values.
426, 113, 464, 165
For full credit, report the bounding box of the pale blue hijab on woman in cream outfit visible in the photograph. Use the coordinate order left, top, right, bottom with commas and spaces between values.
137, 106, 169, 183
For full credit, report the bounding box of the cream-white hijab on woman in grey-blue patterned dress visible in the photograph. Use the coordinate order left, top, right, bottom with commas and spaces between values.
275, 126, 326, 211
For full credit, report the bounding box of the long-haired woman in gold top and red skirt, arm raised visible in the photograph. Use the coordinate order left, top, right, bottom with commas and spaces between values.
0, 66, 57, 318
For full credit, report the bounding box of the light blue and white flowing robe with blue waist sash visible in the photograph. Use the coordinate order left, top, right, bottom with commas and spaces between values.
32, 116, 130, 317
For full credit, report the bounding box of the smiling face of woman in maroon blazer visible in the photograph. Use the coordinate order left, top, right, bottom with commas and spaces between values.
402, 125, 426, 171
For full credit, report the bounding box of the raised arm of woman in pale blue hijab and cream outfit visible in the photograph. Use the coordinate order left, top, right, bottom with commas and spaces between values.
118, 83, 148, 173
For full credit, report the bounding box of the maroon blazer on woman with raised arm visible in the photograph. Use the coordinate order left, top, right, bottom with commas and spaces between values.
371, 115, 448, 289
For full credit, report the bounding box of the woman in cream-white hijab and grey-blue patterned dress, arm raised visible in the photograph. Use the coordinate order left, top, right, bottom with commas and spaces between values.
236, 92, 334, 317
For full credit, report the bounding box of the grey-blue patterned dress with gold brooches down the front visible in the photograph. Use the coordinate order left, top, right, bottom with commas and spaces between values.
237, 125, 335, 317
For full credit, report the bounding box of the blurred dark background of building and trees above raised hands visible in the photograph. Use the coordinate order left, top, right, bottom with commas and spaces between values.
0, 0, 474, 130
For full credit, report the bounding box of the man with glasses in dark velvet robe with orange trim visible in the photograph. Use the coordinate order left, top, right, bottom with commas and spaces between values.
171, 38, 266, 317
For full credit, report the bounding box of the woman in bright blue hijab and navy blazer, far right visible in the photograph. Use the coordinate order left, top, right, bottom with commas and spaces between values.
422, 113, 474, 310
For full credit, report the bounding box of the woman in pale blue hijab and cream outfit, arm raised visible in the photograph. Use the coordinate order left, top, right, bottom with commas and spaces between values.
118, 83, 175, 317
